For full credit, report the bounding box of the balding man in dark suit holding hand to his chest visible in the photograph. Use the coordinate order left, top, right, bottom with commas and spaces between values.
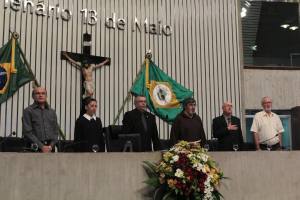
213, 101, 243, 151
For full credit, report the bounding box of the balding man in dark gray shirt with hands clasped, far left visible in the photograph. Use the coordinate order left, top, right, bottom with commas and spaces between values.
22, 87, 59, 153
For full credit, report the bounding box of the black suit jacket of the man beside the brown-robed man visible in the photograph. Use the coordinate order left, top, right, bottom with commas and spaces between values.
123, 109, 161, 151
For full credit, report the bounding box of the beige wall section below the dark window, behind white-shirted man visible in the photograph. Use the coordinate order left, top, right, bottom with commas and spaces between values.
243, 69, 300, 109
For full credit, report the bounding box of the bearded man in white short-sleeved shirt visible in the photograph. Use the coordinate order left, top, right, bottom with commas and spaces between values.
251, 97, 284, 150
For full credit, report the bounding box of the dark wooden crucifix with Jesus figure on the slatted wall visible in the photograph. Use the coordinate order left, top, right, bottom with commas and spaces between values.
61, 33, 110, 114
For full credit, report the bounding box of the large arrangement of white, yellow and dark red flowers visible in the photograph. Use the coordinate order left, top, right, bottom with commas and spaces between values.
144, 141, 224, 200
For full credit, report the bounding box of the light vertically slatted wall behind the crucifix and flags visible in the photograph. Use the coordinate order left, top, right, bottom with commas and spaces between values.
0, 0, 242, 139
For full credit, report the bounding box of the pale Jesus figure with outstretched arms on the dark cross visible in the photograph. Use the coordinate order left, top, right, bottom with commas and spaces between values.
63, 52, 109, 98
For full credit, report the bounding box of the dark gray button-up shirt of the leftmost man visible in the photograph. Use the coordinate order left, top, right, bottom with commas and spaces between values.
23, 103, 59, 149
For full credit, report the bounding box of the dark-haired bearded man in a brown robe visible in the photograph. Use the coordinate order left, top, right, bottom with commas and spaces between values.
170, 98, 206, 146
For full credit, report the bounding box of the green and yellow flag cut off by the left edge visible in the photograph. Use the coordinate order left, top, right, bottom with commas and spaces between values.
0, 37, 34, 104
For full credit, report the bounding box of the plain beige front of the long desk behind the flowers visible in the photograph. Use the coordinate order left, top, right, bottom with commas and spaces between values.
0, 151, 300, 200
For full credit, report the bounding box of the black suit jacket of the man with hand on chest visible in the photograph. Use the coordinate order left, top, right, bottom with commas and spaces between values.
213, 115, 243, 151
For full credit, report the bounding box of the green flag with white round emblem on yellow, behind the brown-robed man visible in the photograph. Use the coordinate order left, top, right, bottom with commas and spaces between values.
130, 58, 193, 122
